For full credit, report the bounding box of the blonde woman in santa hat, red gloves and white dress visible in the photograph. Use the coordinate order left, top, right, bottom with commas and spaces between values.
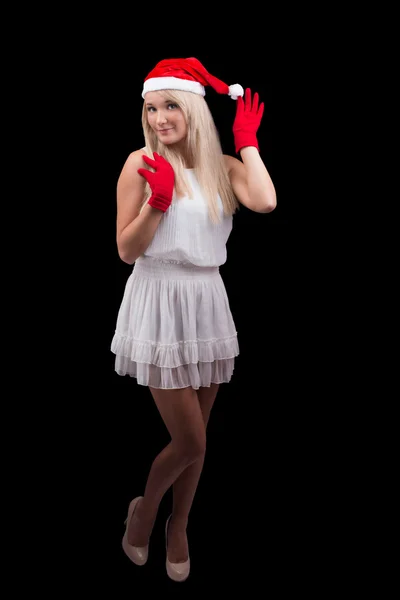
111, 58, 276, 581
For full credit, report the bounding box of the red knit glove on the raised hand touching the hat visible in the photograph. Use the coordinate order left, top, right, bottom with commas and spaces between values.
233, 88, 264, 154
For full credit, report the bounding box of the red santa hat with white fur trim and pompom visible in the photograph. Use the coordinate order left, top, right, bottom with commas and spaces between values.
142, 58, 244, 100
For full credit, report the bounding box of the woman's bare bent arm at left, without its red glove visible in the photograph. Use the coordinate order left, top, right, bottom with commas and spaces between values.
117, 150, 164, 265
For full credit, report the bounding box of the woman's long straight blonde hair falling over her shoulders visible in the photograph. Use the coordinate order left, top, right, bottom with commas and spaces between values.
142, 90, 240, 223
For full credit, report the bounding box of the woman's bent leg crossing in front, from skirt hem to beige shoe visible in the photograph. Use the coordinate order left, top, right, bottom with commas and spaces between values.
128, 387, 206, 546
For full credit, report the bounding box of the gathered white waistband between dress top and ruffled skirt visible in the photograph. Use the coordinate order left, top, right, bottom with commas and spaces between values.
133, 255, 220, 279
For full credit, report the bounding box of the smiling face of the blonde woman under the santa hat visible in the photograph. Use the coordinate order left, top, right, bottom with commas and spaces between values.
145, 92, 187, 144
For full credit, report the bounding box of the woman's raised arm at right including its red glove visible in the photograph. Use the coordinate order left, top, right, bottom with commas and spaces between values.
225, 88, 276, 213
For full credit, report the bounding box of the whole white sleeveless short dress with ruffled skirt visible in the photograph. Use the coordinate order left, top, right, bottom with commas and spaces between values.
111, 169, 239, 389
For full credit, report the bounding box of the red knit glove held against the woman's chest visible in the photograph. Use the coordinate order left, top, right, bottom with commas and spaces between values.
138, 152, 175, 212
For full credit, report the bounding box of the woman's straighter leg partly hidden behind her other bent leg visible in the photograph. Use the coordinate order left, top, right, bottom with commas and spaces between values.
168, 383, 219, 563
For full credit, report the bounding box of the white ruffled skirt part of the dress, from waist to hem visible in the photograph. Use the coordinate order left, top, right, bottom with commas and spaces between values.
111, 256, 239, 389
